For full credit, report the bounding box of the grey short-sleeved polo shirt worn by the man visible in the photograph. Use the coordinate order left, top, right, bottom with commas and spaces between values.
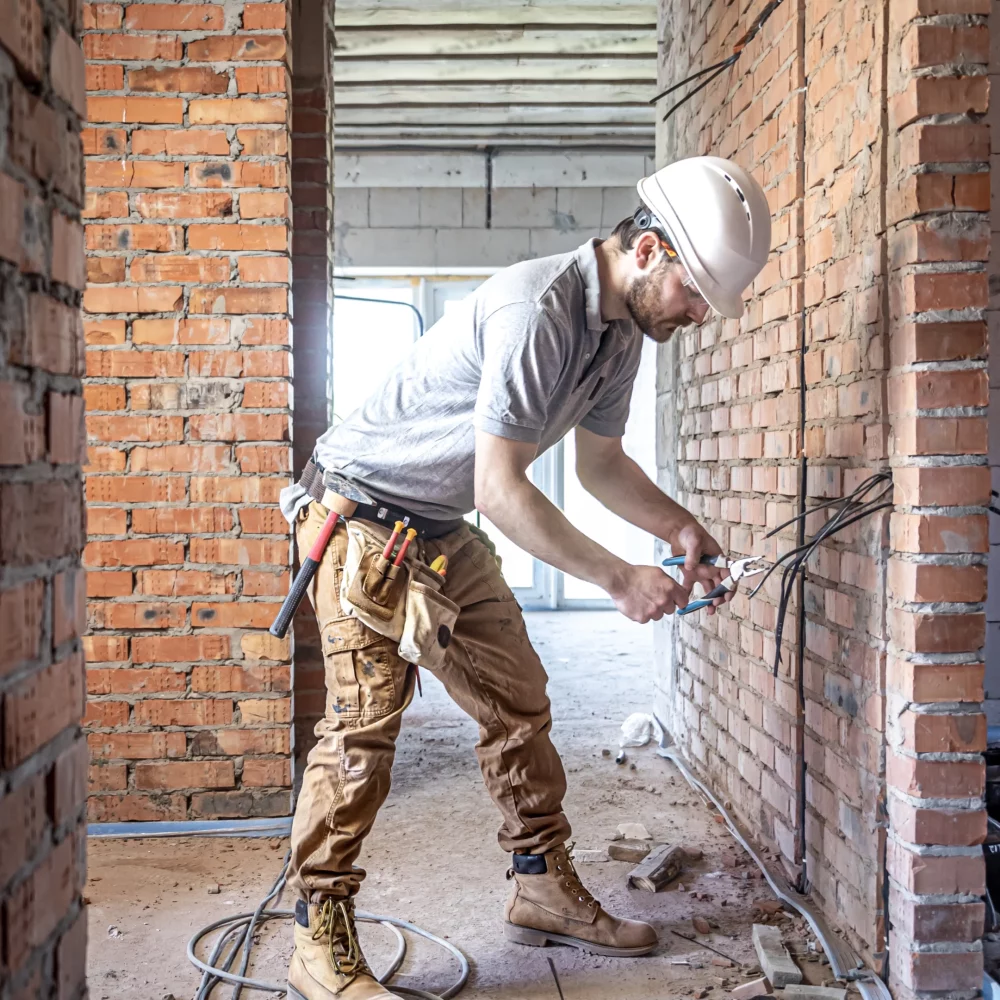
281, 240, 642, 521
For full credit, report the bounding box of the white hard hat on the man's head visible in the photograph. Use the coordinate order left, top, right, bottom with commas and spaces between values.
637, 156, 771, 319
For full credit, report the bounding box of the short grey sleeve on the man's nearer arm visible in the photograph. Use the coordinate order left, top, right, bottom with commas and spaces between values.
474, 302, 566, 442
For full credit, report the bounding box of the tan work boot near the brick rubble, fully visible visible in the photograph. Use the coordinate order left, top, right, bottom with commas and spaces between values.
504, 847, 658, 958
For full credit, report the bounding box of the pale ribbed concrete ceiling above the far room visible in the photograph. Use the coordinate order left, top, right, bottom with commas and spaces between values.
334, 0, 656, 149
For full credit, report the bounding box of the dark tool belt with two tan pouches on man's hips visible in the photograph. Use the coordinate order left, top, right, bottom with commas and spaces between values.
299, 461, 465, 669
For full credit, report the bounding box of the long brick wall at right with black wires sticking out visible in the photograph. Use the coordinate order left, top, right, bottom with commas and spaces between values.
660, 0, 989, 996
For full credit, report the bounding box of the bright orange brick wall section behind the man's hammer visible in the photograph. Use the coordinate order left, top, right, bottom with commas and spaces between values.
84, 0, 291, 821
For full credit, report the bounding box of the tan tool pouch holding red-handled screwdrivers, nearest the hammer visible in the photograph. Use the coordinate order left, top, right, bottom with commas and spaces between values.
340, 521, 409, 642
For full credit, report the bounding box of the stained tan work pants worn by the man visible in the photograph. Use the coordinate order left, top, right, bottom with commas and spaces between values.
289, 502, 570, 899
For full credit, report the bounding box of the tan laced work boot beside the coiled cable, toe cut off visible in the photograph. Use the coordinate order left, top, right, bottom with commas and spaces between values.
288, 897, 399, 1000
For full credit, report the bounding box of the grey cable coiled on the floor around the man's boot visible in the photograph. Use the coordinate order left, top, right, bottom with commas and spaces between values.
187, 855, 470, 1000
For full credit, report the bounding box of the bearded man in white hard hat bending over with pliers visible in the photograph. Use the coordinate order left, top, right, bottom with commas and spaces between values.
282, 157, 771, 1000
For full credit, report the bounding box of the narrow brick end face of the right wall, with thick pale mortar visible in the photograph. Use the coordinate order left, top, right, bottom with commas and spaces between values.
887, 0, 990, 997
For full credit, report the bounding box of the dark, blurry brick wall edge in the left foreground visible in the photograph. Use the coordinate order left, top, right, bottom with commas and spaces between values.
0, 0, 86, 988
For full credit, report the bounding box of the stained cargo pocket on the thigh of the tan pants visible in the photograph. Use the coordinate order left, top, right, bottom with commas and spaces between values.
322, 616, 397, 720
